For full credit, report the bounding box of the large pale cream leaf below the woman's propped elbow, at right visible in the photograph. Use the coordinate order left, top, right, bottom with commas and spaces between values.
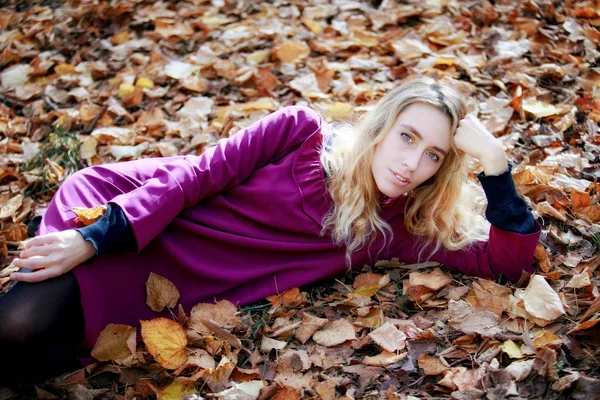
522, 275, 565, 325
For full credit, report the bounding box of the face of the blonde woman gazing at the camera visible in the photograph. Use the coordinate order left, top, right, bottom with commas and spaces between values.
371, 103, 452, 197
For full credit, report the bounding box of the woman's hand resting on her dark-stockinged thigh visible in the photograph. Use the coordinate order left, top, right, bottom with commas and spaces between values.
10, 229, 96, 282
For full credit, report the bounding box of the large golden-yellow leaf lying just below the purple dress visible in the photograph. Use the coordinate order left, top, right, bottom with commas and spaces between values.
140, 318, 187, 369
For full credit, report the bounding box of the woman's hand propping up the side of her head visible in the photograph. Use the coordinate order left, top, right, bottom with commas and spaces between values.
454, 114, 508, 176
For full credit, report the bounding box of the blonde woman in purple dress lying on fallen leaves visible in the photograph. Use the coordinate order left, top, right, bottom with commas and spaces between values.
0, 78, 540, 377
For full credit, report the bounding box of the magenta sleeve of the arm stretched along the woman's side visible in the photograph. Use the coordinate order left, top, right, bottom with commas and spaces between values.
111, 106, 322, 251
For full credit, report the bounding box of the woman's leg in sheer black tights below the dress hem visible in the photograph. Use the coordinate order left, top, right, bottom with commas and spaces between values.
0, 272, 84, 387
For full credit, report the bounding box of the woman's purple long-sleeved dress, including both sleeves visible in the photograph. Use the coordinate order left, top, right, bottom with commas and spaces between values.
39, 107, 539, 348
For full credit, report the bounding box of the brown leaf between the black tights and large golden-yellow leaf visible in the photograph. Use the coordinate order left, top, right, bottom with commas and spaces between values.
91, 324, 136, 362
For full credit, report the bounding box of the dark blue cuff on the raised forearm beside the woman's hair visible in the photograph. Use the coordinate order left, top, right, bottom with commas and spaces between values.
477, 167, 538, 235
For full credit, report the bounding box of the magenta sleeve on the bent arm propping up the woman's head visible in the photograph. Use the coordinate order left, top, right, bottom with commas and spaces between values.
431, 222, 541, 282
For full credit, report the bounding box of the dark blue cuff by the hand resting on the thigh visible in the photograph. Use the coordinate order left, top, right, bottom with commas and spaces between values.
75, 203, 137, 256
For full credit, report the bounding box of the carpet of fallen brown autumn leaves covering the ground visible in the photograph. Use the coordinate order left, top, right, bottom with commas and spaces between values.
0, 0, 600, 400
